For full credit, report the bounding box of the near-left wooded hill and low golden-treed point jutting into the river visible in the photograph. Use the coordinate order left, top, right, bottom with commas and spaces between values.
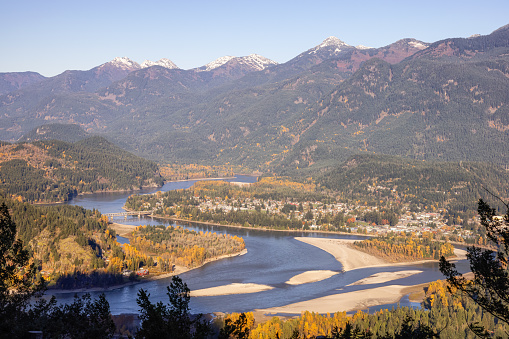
0, 195, 245, 289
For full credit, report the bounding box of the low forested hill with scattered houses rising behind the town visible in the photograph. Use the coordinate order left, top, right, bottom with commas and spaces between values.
317, 154, 509, 212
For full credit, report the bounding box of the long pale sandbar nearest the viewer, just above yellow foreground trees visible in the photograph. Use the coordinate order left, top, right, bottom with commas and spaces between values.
257, 285, 407, 314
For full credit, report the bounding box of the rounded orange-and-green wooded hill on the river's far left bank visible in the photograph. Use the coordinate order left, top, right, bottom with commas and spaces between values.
0, 137, 163, 202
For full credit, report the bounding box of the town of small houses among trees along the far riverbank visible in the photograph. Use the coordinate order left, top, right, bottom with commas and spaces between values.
126, 183, 485, 245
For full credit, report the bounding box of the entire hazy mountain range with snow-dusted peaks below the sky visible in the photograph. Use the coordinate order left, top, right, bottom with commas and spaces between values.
0, 25, 509, 172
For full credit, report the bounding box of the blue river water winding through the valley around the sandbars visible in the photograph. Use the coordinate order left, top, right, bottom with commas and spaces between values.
49, 176, 468, 314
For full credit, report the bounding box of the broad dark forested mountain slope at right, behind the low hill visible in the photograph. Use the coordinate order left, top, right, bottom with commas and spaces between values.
278, 29, 509, 168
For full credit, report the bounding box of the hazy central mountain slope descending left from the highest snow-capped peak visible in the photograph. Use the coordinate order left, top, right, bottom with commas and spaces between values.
105, 38, 426, 163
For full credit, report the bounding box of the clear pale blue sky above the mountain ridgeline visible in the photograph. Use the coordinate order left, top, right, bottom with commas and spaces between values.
0, 0, 509, 76
